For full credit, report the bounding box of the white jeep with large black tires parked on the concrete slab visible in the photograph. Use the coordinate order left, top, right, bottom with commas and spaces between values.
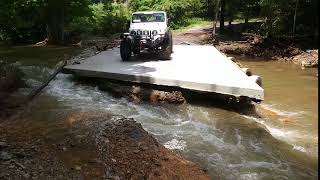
120, 11, 172, 61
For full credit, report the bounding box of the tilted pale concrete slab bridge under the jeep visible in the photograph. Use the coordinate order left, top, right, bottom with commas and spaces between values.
65, 45, 264, 100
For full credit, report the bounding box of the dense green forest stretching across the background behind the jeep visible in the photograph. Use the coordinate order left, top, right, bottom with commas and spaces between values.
0, 0, 319, 44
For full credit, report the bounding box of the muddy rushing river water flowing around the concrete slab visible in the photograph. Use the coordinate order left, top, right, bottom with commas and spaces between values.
0, 48, 318, 179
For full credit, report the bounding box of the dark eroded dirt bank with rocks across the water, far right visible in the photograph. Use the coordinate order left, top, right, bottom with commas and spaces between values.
209, 33, 318, 68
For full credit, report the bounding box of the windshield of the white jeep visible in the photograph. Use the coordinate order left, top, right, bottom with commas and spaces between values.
132, 13, 165, 23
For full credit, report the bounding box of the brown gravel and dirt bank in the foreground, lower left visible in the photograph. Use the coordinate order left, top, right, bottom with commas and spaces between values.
0, 112, 210, 180
